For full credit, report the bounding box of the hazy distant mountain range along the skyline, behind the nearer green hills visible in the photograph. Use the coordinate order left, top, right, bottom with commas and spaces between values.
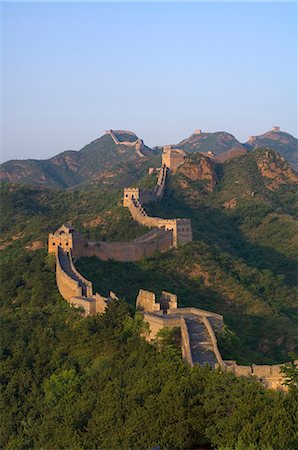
0, 129, 298, 189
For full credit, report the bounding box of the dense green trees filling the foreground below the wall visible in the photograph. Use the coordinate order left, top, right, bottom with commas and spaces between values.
0, 251, 298, 450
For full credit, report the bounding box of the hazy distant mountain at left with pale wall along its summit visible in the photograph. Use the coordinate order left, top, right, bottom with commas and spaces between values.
0, 131, 158, 188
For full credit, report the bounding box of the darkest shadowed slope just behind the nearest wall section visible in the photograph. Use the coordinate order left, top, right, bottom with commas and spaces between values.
77, 252, 292, 364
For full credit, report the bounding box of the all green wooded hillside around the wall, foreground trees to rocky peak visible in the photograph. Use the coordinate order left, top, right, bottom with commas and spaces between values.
0, 149, 298, 450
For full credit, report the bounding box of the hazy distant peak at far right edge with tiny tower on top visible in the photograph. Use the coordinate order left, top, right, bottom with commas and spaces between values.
244, 128, 298, 172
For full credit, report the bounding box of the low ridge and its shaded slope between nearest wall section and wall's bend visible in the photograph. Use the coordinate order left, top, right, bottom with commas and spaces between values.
77, 241, 298, 364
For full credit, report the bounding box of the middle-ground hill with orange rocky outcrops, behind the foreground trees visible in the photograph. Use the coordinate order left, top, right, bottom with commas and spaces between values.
1, 149, 298, 362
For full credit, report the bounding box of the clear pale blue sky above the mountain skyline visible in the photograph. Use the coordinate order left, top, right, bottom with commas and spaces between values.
1, 2, 297, 161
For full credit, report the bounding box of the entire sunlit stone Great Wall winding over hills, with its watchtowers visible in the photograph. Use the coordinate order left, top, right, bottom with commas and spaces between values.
48, 130, 298, 390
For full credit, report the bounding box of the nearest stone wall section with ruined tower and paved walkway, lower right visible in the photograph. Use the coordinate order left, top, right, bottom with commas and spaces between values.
136, 290, 298, 391
